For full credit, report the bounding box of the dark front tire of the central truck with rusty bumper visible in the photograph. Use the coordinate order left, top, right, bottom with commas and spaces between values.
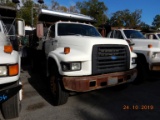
49, 65, 69, 106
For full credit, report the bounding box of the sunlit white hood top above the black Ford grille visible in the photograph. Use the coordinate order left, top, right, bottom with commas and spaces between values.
58, 36, 128, 53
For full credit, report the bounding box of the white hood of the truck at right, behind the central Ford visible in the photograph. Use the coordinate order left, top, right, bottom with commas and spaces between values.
132, 39, 160, 48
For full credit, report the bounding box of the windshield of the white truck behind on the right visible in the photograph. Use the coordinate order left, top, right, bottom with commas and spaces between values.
124, 30, 146, 39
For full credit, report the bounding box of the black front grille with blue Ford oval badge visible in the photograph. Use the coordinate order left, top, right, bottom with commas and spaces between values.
92, 44, 130, 74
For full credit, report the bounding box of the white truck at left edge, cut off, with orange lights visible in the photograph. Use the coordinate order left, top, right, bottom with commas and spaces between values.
0, 6, 24, 119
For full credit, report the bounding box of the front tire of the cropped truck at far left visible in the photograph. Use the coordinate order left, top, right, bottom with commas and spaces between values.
1, 85, 21, 119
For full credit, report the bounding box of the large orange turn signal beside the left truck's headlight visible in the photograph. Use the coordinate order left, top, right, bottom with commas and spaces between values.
9, 64, 19, 76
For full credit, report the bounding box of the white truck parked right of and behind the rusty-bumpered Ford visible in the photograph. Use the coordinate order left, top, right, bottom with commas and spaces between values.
107, 29, 160, 81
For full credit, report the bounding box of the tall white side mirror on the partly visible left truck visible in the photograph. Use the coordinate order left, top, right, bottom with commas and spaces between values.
16, 18, 25, 36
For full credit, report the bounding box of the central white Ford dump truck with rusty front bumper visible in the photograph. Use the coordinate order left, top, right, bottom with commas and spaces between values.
31, 9, 137, 105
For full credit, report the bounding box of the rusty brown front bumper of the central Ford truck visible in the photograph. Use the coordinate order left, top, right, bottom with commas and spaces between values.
62, 69, 137, 92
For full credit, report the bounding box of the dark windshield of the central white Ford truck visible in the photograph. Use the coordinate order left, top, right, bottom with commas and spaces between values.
58, 23, 101, 37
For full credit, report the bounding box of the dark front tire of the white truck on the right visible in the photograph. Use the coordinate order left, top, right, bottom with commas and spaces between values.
133, 56, 149, 84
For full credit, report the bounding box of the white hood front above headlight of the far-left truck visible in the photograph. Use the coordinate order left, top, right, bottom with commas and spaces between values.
0, 46, 18, 64
